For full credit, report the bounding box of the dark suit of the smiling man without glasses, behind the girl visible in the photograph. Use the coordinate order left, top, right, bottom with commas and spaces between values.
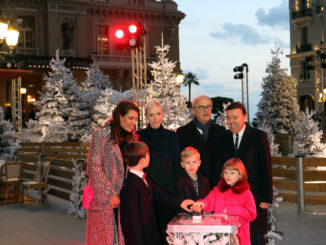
215, 125, 273, 239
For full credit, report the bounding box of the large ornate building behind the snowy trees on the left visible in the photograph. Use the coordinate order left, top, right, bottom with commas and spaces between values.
0, 0, 185, 119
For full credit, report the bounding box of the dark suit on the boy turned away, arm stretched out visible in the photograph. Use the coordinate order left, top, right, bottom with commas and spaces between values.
120, 172, 181, 245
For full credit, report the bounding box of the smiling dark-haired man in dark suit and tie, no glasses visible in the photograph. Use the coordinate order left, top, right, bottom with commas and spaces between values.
215, 102, 273, 245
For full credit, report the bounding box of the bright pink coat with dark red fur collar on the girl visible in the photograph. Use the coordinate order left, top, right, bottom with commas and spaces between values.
198, 179, 257, 245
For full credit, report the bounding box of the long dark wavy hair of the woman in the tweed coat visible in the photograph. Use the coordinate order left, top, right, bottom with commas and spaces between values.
107, 100, 139, 144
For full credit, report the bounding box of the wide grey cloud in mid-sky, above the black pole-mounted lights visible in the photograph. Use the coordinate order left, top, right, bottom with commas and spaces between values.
210, 22, 270, 46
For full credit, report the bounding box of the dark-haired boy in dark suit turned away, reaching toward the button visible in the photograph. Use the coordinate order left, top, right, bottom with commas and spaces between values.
120, 141, 194, 245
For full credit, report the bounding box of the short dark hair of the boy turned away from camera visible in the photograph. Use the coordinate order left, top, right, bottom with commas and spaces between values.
123, 141, 149, 167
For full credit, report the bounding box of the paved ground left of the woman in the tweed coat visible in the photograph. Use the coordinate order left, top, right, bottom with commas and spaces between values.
0, 195, 86, 245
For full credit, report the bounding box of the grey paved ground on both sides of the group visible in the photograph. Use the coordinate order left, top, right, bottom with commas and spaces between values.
0, 197, 326, 245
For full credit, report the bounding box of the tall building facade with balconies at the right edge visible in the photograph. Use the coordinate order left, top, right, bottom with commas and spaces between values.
288, 0, 326, 113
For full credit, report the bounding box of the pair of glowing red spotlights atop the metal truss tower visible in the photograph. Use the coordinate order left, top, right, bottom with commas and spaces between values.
114, 23, 144, 49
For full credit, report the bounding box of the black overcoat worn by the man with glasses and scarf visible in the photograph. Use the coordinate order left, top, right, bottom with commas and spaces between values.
177, 121, 225, 186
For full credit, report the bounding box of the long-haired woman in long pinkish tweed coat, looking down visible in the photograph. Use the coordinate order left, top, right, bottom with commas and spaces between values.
86, 100, 139, 245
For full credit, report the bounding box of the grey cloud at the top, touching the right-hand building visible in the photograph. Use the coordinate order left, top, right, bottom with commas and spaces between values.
256, 0, 289, 29
